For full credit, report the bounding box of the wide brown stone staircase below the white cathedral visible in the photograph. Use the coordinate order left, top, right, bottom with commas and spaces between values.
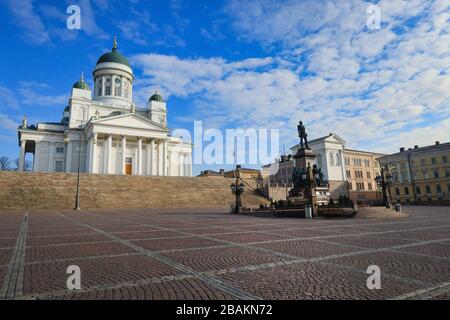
0, 172, 268, 210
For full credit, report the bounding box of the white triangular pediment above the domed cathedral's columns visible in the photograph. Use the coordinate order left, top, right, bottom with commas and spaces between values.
92, 113, 169, 132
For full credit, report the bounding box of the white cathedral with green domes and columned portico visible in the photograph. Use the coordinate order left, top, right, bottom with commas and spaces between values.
18, 40, 192, 176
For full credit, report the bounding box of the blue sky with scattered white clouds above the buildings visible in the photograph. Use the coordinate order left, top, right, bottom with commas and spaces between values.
0, 0, 450, 171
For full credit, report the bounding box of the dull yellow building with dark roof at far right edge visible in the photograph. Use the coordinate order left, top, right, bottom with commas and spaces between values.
378, 141, 450, 203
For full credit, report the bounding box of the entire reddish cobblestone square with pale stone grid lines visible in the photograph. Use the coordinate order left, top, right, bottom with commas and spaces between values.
0, 206, 450, 300
